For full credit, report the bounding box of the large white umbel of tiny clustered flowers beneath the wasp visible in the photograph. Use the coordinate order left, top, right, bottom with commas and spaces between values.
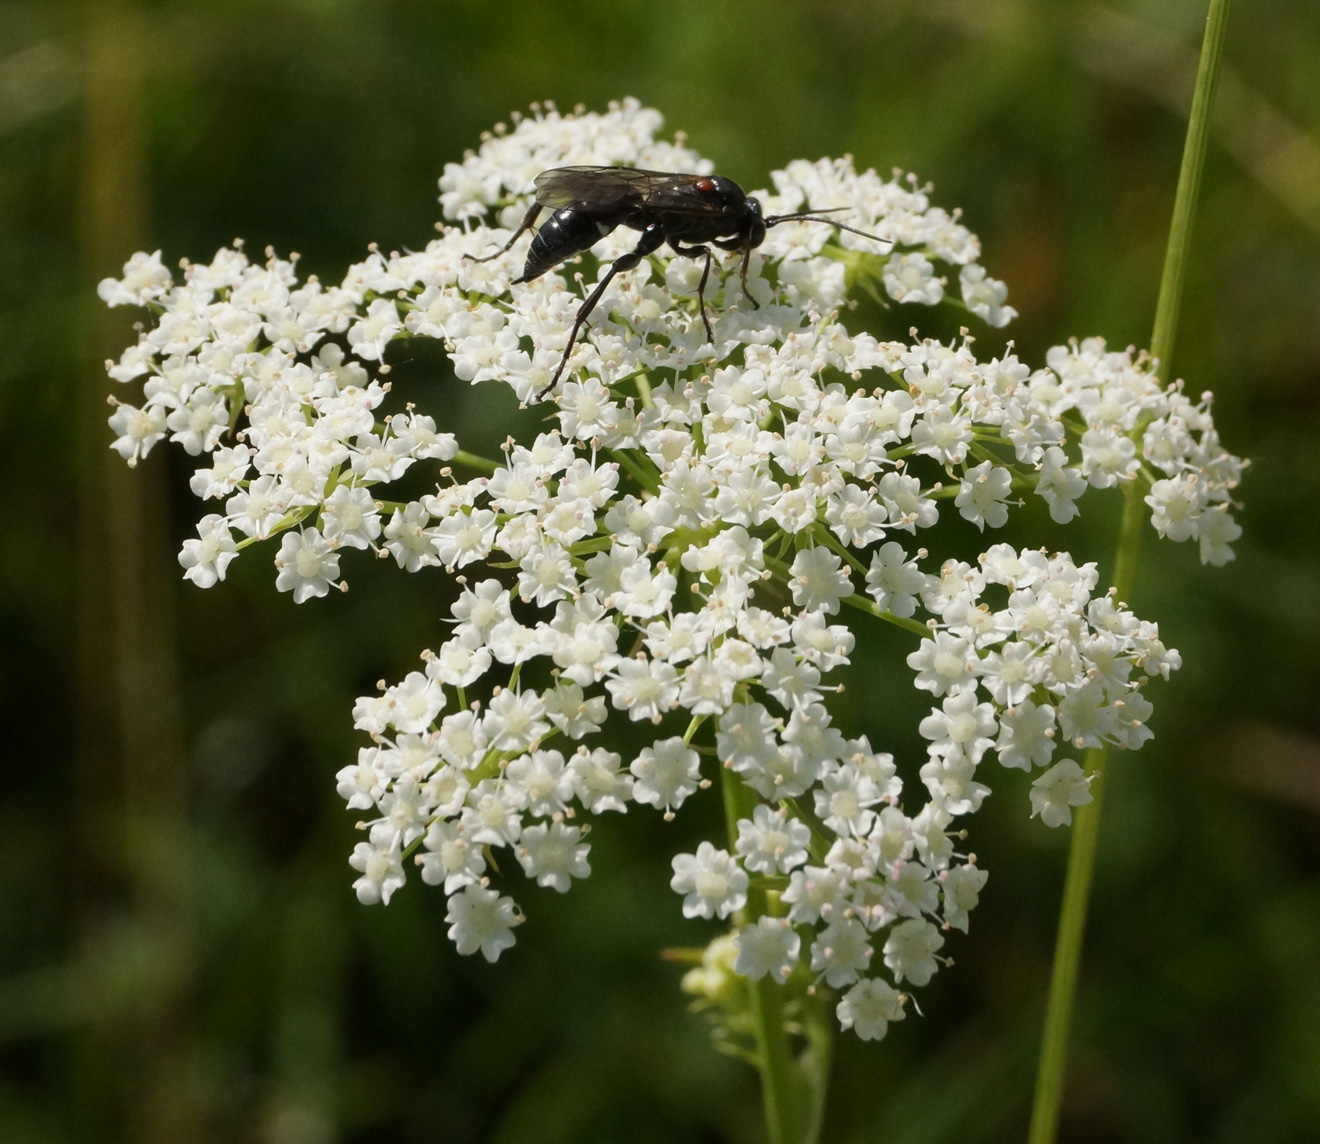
100, 102, 1243, 1037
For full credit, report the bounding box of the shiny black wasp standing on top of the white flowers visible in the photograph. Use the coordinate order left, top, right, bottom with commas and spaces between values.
475, 166, 886, 398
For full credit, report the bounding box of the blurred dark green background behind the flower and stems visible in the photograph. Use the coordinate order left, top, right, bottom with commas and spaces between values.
0, 0, 1320, 1144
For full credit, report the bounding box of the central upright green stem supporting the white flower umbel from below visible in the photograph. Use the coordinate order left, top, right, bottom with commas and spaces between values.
719, 767, 801, 1144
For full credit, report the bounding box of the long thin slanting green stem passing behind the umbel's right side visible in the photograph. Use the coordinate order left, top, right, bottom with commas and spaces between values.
1027, 0, 1229, 1144
